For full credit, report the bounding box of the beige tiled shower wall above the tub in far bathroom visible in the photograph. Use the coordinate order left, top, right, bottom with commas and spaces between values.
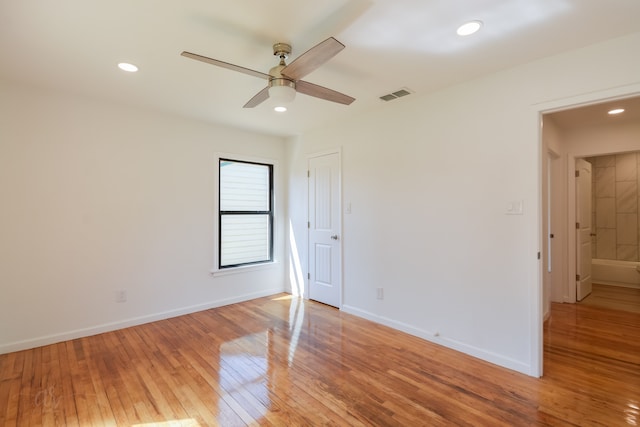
586, 153, 640, 261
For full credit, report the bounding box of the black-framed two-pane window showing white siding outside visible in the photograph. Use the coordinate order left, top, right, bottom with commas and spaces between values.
218, 159, 273, 269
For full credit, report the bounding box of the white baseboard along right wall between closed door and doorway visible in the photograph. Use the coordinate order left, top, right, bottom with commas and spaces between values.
342, 305, 532, 375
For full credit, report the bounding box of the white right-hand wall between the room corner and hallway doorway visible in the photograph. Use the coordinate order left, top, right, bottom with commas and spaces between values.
289, 34, 640, 375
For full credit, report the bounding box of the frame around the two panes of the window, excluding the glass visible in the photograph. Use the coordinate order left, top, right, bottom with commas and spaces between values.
216, 155, 275, 272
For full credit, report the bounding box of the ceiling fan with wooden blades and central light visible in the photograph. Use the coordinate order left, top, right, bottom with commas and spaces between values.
181, 37, 355, 108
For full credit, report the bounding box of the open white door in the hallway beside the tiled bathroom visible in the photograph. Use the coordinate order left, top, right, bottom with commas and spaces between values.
576, 159, 591, 301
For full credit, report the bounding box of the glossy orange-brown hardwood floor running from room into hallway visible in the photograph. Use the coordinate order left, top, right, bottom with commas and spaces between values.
0, 294, 640, 426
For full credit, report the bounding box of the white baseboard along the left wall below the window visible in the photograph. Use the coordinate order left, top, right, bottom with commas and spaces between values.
0, 289, 283, 354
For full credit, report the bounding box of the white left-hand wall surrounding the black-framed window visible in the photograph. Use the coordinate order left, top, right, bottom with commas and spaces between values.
0, 82, 287, 353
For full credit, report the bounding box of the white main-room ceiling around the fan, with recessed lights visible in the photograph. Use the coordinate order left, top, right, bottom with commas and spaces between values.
0, 0, 640, 135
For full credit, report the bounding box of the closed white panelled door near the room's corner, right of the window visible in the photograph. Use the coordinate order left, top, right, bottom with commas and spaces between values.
308, 153, 342, 307
